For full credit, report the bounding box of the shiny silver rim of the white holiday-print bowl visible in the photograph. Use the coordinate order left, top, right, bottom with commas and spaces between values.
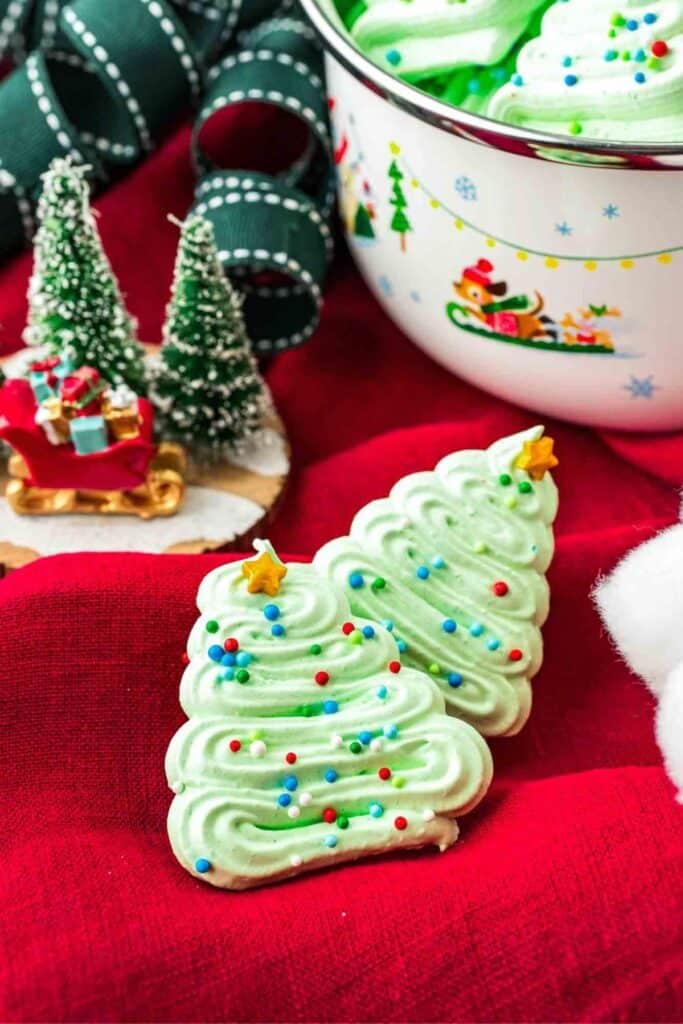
300, 0, 683, 171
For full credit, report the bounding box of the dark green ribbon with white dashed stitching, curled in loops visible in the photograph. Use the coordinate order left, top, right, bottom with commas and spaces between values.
0, 0, 334, 352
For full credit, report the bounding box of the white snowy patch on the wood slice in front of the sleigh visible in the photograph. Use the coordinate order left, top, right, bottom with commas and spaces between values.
0, 487, 264, 555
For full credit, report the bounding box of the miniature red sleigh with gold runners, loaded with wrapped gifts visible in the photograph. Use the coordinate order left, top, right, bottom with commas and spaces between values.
0, 358, 185, 519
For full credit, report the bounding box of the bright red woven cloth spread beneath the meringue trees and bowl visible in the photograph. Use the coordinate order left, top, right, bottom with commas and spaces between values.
0, 133, 683, 1022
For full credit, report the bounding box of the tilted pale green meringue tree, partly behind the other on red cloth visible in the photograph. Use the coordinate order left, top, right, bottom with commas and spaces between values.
313, 427, 558, 736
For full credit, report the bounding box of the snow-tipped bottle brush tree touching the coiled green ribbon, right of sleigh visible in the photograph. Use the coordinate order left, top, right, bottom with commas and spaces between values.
153, 217, 268, 453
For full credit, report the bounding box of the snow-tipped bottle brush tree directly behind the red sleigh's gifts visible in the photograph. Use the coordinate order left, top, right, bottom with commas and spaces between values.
25, 159, 145, 394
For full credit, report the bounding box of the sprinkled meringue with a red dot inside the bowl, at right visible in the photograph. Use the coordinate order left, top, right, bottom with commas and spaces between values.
488, 0, 683, 142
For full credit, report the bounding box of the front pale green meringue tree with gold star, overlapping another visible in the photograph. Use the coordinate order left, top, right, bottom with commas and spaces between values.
166, 542, 492, 889
